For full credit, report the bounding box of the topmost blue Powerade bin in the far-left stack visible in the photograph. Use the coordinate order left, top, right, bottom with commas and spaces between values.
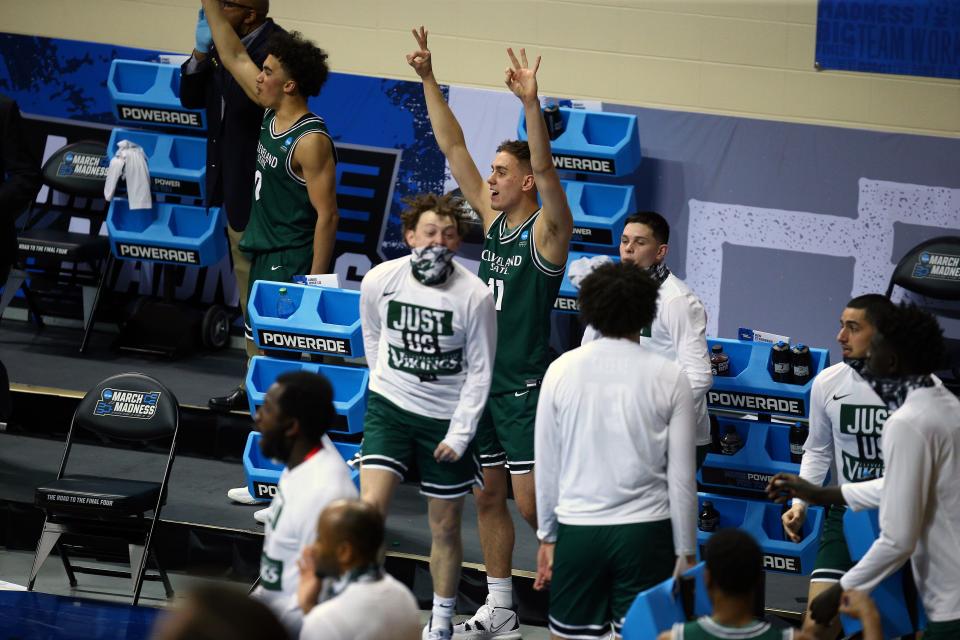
107, 59, 207, 132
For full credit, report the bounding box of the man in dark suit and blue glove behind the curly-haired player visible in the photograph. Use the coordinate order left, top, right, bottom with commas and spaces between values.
180, 0, 283, 411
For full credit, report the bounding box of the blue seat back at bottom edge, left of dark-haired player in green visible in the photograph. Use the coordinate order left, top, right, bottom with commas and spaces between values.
621, 562, 713, 640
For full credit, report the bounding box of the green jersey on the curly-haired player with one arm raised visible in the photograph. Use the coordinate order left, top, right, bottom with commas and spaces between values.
240, 109, 337, 253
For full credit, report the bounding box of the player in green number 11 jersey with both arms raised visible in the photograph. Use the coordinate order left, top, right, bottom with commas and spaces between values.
407, 27, 573, 638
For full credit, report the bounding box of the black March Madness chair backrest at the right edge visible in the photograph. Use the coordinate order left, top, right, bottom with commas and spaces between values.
887, 236, 960, 300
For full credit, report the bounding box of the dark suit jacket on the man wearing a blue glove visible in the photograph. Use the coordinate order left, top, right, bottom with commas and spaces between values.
180, 18, 283, 231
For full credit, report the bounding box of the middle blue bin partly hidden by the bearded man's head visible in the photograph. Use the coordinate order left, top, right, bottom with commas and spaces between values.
246, 356, 370, 433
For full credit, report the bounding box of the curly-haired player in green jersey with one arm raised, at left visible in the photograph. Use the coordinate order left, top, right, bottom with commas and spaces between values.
203, 0, 339, 298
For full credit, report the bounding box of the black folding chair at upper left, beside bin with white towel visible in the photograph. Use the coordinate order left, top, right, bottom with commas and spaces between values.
0, 141, 113, 353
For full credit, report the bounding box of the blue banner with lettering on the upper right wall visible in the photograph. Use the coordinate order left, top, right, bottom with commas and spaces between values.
816, 0, 960, 78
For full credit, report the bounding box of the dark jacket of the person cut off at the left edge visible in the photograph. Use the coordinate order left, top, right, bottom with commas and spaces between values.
0, 95, 40, 272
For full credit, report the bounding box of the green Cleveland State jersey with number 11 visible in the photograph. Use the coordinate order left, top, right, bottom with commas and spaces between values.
477, 211, 565, 395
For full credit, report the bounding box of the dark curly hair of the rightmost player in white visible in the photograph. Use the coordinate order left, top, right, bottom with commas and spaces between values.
874, 302, 946, 374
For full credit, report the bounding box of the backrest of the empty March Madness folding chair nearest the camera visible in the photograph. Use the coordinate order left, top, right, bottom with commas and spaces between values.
73, 373, 180, 441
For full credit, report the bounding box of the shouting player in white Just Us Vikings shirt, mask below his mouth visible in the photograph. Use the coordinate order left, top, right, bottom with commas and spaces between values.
360, 194, 497, 638
